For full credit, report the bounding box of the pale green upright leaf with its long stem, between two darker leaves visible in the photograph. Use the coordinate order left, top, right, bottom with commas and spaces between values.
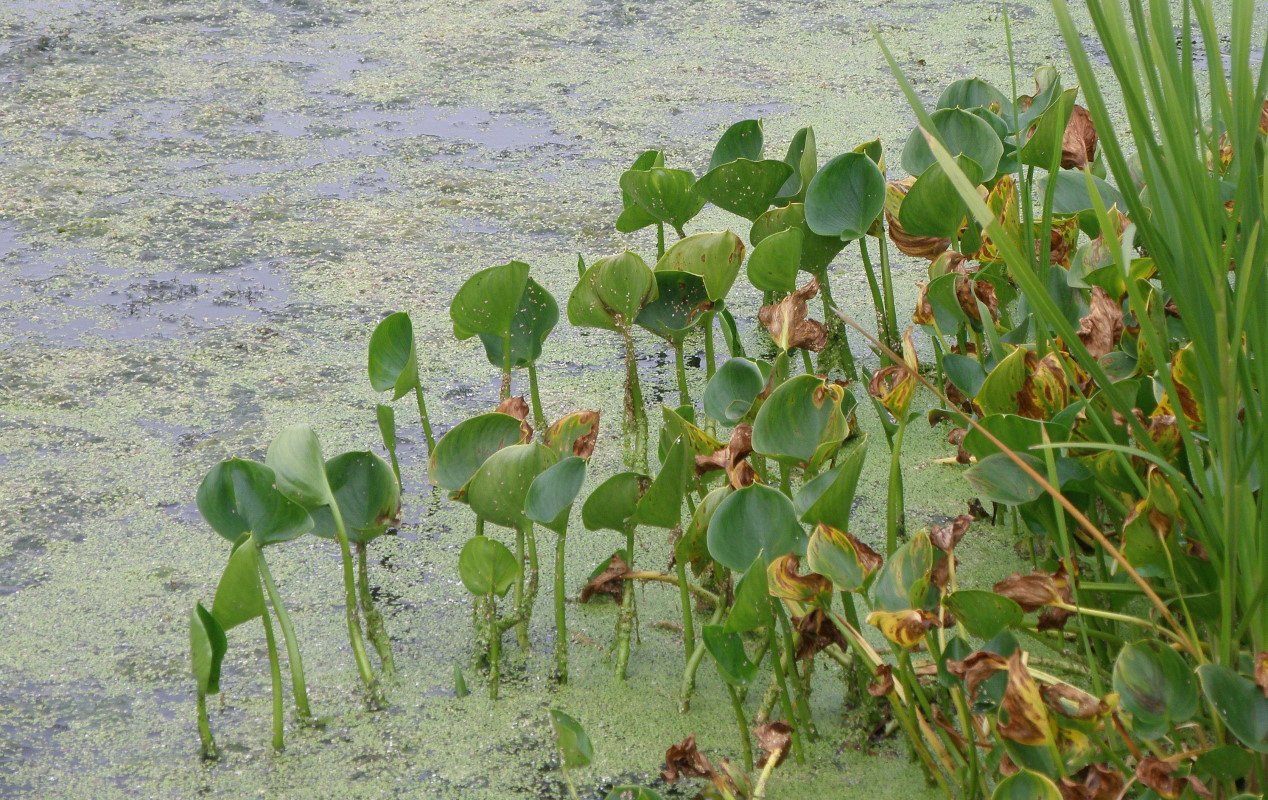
265, 425, 382, 707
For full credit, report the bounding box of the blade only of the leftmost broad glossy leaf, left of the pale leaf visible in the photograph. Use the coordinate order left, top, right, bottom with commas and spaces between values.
198, 459, 313, 545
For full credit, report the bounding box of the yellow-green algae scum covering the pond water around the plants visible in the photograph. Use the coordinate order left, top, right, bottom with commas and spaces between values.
0, 0, 1058, 797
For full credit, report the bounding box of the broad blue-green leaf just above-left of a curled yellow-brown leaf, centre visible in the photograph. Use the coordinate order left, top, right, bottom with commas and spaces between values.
708, 483, 806, 572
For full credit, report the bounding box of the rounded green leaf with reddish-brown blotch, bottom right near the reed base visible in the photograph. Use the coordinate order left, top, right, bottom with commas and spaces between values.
1113, 639, 1196, 739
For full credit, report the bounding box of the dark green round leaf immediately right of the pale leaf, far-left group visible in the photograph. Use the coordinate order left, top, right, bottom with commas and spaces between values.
313, 450, 401, 541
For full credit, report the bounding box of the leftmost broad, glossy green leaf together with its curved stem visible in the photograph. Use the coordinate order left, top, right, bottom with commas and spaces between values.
198, 459, 313, 720
